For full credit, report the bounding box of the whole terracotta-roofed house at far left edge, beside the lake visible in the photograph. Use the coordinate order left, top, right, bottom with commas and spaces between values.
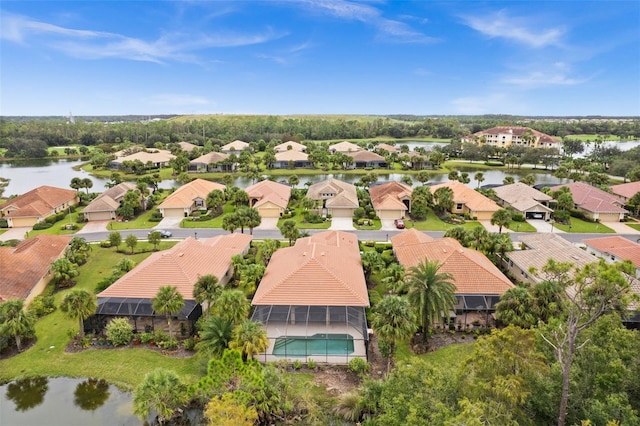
0, 185, 80, 228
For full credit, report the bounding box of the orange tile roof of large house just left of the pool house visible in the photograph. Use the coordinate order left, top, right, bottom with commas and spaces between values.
98, 233, 252, 300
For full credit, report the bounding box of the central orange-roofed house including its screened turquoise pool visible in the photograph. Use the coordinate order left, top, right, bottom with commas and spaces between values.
251, 231, 369, 364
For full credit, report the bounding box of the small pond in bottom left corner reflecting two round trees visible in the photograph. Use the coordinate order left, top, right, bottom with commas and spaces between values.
0, 377, 145, 426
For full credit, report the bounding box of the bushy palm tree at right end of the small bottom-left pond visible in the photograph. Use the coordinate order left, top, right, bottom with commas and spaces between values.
133, 368, 187, 424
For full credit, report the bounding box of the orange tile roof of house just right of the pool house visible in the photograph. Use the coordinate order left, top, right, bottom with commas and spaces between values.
391, 235, 513, 295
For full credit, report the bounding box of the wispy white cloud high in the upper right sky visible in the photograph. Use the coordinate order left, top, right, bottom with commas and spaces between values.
462, 10, 565, 48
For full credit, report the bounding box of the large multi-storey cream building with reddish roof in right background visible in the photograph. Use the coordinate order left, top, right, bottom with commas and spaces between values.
462, 126, 562, 149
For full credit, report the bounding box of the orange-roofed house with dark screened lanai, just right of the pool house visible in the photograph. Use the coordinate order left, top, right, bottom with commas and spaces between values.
391, 229, 514, 328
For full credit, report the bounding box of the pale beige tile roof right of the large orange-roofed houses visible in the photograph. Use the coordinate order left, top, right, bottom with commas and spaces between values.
506, 232, 595, 281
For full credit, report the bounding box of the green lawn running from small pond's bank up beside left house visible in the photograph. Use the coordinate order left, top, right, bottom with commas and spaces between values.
0, 242, 206, 389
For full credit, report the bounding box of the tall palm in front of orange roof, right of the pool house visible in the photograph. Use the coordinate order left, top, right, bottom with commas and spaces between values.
405, 259, 456, 342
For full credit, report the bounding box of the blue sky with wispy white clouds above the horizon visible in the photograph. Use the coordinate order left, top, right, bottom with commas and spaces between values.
0, 0, 640, 116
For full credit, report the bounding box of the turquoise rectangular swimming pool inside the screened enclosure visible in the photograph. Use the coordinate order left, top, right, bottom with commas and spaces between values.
273, 333, 353, 357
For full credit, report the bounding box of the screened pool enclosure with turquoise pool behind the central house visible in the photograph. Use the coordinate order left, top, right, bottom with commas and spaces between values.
252, 305, 368, 364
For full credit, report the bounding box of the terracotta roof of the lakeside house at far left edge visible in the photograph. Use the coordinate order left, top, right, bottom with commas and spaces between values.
0, 185, 78, 217
